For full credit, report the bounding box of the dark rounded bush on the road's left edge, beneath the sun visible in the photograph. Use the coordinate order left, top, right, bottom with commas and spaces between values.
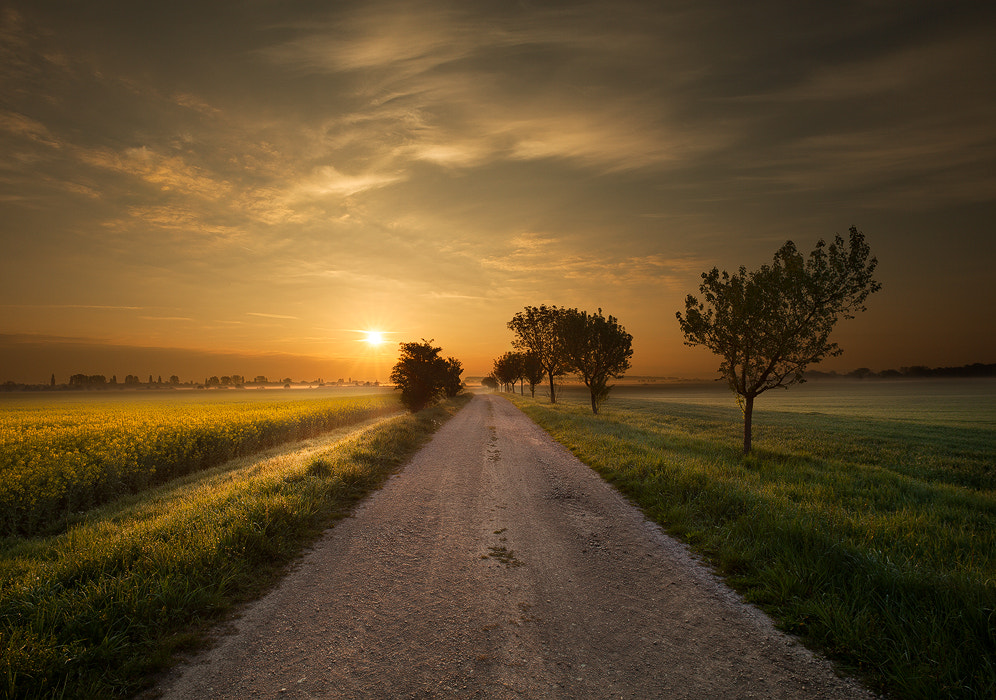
391, 338, 463, 413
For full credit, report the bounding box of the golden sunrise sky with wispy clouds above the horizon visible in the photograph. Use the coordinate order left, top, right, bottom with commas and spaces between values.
0, 0, 996, 382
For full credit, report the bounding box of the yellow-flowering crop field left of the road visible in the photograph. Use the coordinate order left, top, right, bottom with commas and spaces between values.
0, 389, 400, 536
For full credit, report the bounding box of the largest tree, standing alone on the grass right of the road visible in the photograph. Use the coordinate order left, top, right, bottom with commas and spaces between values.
676, 226, 882, 454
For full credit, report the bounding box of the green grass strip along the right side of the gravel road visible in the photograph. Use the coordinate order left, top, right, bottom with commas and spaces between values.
506, 395, 996, 699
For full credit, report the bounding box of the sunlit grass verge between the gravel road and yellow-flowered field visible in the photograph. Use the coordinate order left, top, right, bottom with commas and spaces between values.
0, 396, 469, 698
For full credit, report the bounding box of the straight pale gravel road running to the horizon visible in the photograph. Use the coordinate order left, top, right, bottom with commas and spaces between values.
162, 396, 872, 699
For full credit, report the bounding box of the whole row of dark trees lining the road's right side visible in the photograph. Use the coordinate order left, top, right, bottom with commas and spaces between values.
489, 226, 882, 454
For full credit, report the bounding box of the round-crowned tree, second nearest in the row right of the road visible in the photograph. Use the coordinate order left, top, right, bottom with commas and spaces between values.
560, 309, 633, 414
